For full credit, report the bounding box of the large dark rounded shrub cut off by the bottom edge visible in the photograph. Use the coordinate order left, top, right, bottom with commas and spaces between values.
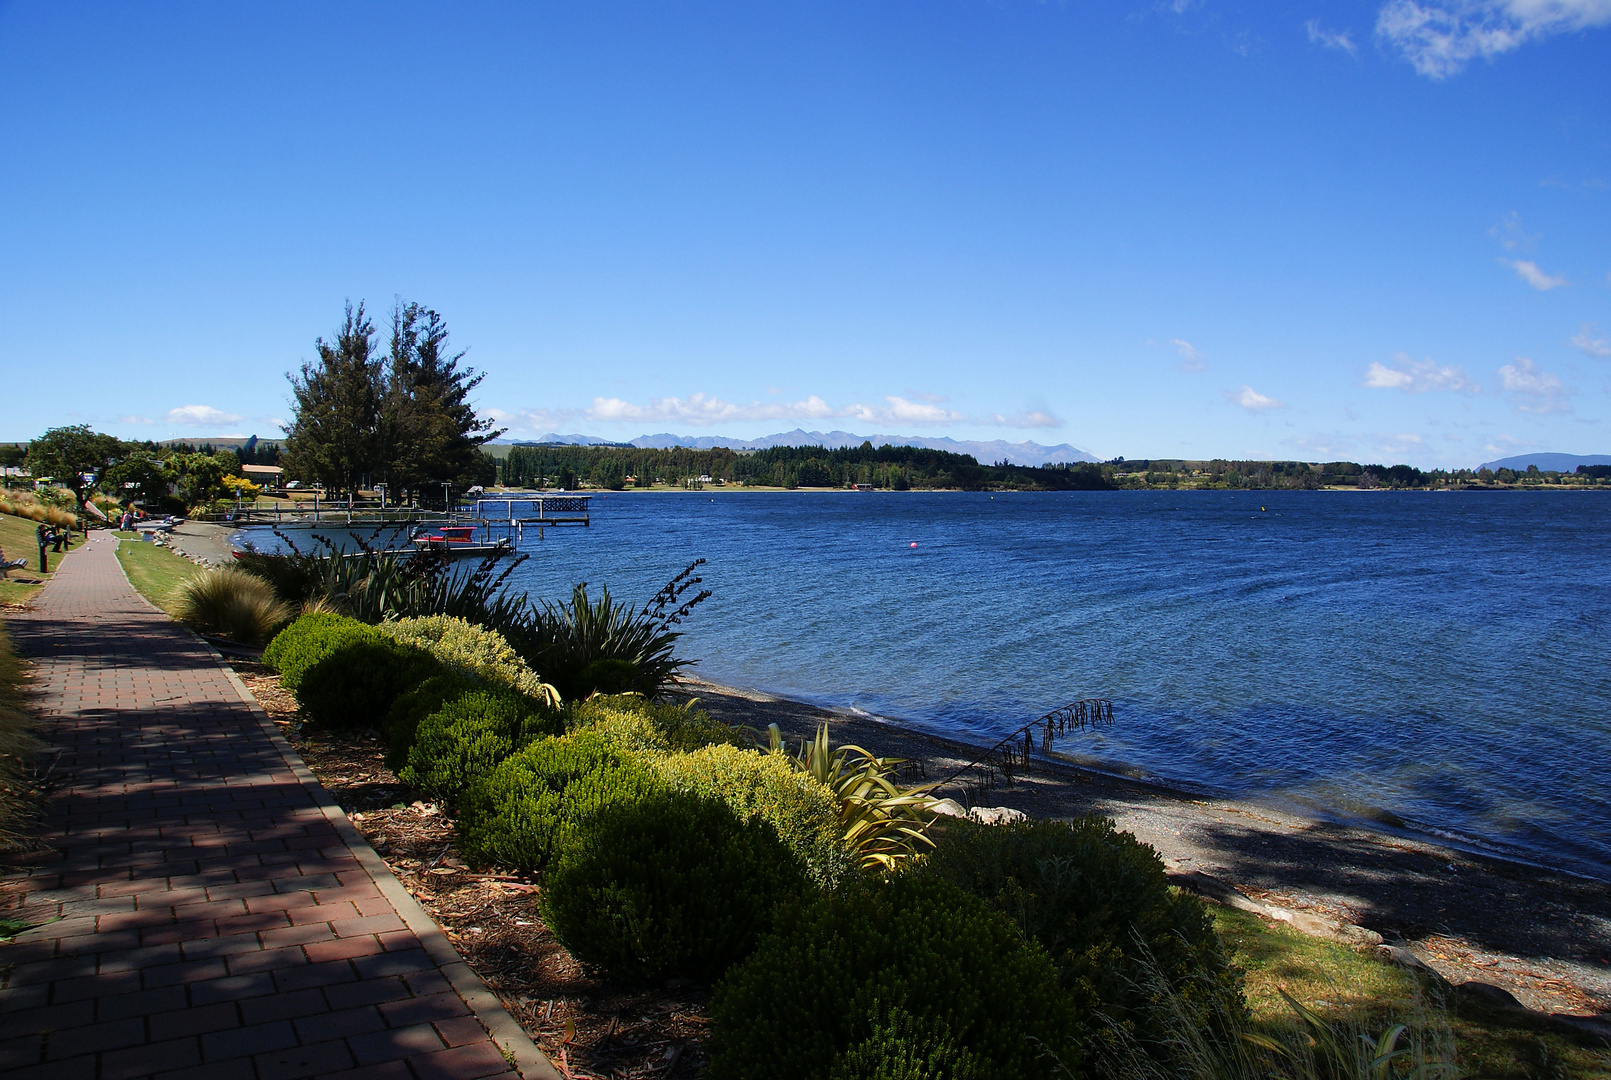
709, 874, 1083, 1080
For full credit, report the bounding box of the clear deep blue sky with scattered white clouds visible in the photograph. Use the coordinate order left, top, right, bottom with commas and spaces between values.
0, 0, 1611, 466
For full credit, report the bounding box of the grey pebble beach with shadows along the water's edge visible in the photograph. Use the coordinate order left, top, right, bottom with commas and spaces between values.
677, 677, 1611, 1014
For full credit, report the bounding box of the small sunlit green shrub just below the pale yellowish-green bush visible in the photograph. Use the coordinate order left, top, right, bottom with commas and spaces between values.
398, 688, 561, 806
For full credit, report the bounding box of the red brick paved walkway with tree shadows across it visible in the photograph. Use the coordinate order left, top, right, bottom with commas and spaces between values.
0, 534, 557, 1080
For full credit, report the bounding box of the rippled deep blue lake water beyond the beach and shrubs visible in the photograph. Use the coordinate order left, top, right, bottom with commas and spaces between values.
238, 492, 1611, 877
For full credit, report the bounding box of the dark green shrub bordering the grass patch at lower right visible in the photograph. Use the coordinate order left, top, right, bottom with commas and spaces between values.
921, 814, 1244, 1057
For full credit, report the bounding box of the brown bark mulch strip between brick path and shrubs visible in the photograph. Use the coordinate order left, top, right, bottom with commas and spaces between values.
232, 659, 709, 1080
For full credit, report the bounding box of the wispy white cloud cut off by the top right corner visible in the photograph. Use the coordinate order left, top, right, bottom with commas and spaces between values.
1376, 0, 1611, 79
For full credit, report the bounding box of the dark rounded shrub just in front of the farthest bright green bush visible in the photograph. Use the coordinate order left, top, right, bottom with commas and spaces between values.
296, 638, 441, 727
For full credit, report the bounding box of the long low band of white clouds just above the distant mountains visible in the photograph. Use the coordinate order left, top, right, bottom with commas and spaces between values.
487, 393, 1063, 430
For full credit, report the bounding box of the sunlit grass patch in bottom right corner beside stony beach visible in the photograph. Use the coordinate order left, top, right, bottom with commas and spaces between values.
1215, 908, 1611, 1080
